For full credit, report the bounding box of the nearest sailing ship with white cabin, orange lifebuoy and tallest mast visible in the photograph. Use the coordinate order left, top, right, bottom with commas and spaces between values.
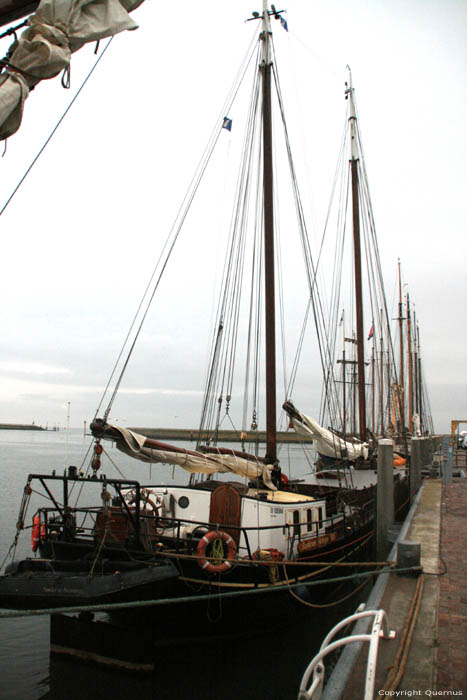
0, 2, 406, 634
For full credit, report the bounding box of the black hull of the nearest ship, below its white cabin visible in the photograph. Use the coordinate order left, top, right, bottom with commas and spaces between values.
111, 533, 373, 648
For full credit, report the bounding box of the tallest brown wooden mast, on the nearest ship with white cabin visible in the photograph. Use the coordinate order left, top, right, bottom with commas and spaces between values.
261, 0, 277, 464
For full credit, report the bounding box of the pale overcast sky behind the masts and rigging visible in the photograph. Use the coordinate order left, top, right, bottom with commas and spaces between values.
0, 0, 467, 432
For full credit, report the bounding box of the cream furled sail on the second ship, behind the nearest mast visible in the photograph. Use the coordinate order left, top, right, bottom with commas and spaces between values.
283, 401, 368, 462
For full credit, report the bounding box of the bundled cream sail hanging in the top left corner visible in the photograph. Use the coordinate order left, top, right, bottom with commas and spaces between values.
0, 0, 143, 139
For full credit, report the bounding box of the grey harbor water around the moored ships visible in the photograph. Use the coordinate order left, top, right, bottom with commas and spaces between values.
0, 430, 358, 700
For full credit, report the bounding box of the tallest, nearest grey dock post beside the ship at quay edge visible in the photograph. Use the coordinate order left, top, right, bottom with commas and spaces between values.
376, 440, 394, 561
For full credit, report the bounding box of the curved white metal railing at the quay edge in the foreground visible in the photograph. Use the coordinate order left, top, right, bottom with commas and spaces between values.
298, 610, 396, 700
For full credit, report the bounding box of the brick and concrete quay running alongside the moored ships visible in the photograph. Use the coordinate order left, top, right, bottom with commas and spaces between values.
323, 478, 467, 700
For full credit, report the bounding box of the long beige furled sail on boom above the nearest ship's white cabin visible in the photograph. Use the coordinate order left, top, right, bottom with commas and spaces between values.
104, 423, 276, 491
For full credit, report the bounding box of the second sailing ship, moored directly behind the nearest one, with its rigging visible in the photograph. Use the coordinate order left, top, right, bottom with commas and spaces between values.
284, 68, 414, 478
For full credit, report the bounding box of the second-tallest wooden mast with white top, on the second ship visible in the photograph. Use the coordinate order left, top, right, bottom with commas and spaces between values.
346, 71, 366, 441
